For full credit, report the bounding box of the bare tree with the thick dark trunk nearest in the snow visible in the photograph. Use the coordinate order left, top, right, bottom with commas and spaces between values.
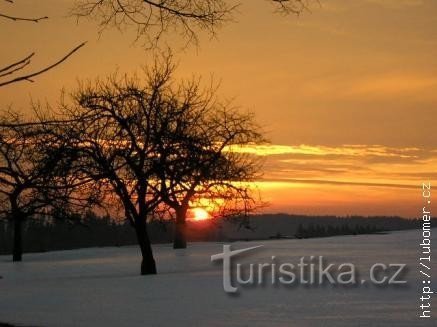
56, 72, 169, 275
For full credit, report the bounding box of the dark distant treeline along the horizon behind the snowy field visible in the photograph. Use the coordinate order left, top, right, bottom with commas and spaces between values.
0, 213, 437, 254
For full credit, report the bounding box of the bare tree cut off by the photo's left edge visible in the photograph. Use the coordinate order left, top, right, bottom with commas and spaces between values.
0, 113, 93, 261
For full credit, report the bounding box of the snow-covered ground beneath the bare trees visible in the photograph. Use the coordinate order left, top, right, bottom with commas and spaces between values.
0, 231, 437, 327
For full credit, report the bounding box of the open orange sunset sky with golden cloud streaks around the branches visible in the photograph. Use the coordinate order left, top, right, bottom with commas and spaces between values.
0, 0, 437, 217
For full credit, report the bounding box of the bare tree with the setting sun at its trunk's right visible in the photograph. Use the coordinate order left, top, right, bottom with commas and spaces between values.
150, 87, 266, 249
